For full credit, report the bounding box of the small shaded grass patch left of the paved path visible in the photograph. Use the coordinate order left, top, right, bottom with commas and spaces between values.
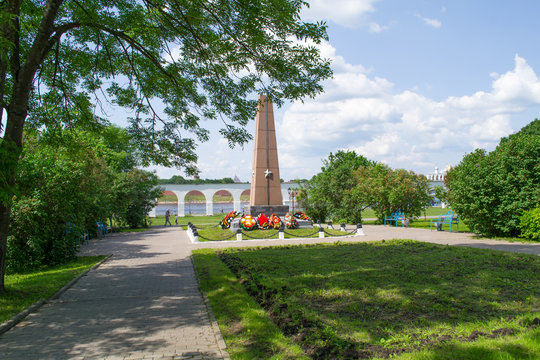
0, 256, 105, 323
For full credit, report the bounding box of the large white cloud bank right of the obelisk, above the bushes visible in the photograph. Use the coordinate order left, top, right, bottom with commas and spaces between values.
277, 45, 540, 177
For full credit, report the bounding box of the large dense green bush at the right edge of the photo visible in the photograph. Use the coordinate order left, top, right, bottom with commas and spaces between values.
445, 120, 540, 236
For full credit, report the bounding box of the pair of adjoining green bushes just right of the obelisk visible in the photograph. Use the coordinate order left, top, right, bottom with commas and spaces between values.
298, 151, 431, 223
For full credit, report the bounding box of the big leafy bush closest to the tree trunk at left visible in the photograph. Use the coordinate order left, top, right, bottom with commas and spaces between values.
7, 136, 108, 272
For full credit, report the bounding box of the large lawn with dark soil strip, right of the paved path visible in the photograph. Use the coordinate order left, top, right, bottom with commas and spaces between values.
193, 240, 540, 359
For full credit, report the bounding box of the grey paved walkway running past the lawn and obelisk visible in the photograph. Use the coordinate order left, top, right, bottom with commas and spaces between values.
0, 226, 540, 360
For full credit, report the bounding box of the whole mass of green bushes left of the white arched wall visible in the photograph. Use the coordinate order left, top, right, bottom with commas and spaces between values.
7, 127, 161, 272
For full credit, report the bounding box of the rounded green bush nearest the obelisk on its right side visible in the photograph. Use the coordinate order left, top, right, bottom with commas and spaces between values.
298, 150, 375, 223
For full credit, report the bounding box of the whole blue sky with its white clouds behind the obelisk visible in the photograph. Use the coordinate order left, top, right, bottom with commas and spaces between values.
156, 0, 540, 181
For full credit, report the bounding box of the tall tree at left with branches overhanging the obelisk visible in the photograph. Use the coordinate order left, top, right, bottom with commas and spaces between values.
0, 0, 331, 294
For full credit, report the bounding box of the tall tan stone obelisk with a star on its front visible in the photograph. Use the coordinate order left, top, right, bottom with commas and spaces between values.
246, 95, 289, 216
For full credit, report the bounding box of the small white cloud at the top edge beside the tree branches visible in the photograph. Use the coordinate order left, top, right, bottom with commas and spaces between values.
302, 0, 386, 29
